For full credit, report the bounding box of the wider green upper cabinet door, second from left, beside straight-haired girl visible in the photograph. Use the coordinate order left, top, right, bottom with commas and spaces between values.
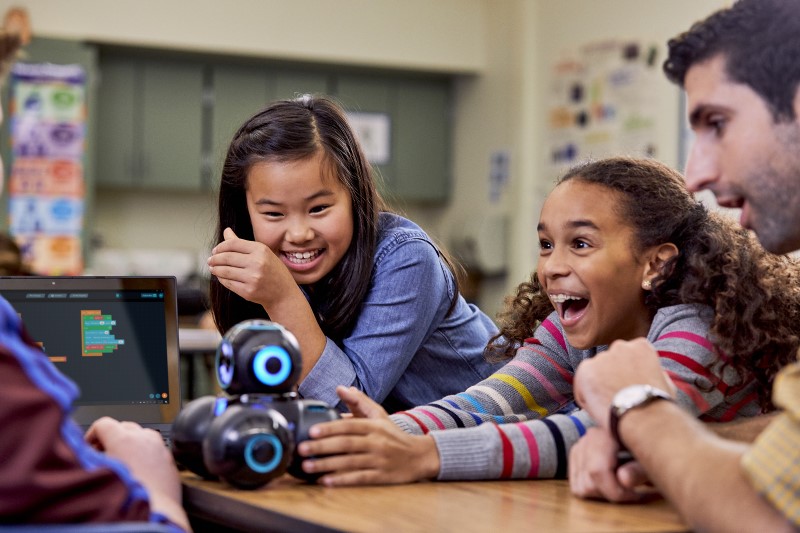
139, 59, 204, 190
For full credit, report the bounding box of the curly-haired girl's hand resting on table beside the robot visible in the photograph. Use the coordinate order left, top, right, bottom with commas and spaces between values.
298, 387, 439, 486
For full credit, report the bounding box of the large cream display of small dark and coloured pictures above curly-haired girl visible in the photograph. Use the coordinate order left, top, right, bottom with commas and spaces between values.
548, 41, 660, 179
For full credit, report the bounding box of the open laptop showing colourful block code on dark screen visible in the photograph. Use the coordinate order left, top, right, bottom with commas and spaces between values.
0, 276, 181, 444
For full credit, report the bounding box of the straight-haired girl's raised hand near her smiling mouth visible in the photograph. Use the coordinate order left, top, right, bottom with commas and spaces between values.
208, 228, 297, 309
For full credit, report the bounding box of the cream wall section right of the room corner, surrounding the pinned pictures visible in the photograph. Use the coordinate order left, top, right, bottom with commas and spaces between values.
507, 0, 729, 316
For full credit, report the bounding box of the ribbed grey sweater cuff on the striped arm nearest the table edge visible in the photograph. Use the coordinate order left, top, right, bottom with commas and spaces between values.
430, 424, 502, 481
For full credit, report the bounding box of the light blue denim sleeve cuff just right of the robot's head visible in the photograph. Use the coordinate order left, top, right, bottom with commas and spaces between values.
297, 339, 356, 411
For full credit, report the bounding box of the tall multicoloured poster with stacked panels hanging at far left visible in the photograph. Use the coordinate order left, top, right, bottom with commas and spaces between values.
8, 63, 86, 275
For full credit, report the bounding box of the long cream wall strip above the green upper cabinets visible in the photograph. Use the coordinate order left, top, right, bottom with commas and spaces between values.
6, 0, 484, 72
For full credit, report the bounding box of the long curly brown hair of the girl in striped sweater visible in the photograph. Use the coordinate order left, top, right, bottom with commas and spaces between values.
487, 157, 800, 410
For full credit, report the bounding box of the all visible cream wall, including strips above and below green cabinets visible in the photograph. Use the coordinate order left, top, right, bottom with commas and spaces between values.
0, 0, 728, 313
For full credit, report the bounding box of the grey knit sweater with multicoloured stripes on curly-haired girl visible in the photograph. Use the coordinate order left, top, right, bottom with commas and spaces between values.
392, 305, 760, 480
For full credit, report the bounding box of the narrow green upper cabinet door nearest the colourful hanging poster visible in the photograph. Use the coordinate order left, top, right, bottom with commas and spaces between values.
96, 57, 142, 186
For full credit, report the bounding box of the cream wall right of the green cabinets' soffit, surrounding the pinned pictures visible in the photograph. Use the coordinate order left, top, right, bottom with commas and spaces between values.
435, 0, 728, 312
